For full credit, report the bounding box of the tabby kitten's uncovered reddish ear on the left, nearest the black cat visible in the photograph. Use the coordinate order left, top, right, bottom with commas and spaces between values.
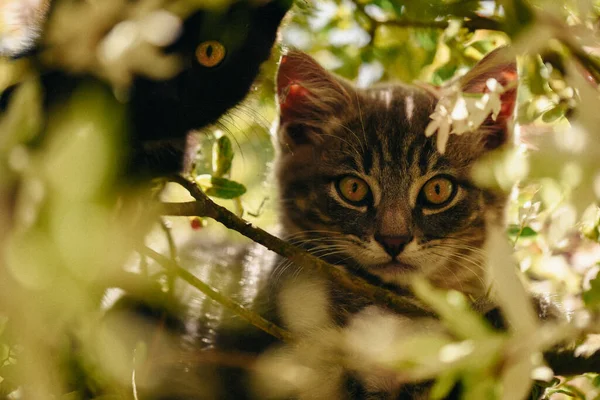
277, 51, 352, 145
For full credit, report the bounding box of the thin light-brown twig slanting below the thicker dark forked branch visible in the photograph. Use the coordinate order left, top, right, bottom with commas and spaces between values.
140, 247, 292, 342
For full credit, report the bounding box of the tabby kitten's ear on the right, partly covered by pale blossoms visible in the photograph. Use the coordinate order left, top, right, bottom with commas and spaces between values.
460, 47, 518, 150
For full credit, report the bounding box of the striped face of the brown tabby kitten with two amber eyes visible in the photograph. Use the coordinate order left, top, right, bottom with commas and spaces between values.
277, 53, 516, 294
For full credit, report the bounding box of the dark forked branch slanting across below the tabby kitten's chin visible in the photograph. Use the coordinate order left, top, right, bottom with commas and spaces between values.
161, 175, 433, 316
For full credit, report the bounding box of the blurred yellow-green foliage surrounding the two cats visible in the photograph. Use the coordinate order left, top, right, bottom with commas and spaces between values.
0, 0, 600, 399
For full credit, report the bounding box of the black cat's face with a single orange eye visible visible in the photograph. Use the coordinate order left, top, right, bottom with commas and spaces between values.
146, 0, 291, 129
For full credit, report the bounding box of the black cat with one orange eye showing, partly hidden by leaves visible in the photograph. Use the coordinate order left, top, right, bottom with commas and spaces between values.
0, 0, 292, 179
